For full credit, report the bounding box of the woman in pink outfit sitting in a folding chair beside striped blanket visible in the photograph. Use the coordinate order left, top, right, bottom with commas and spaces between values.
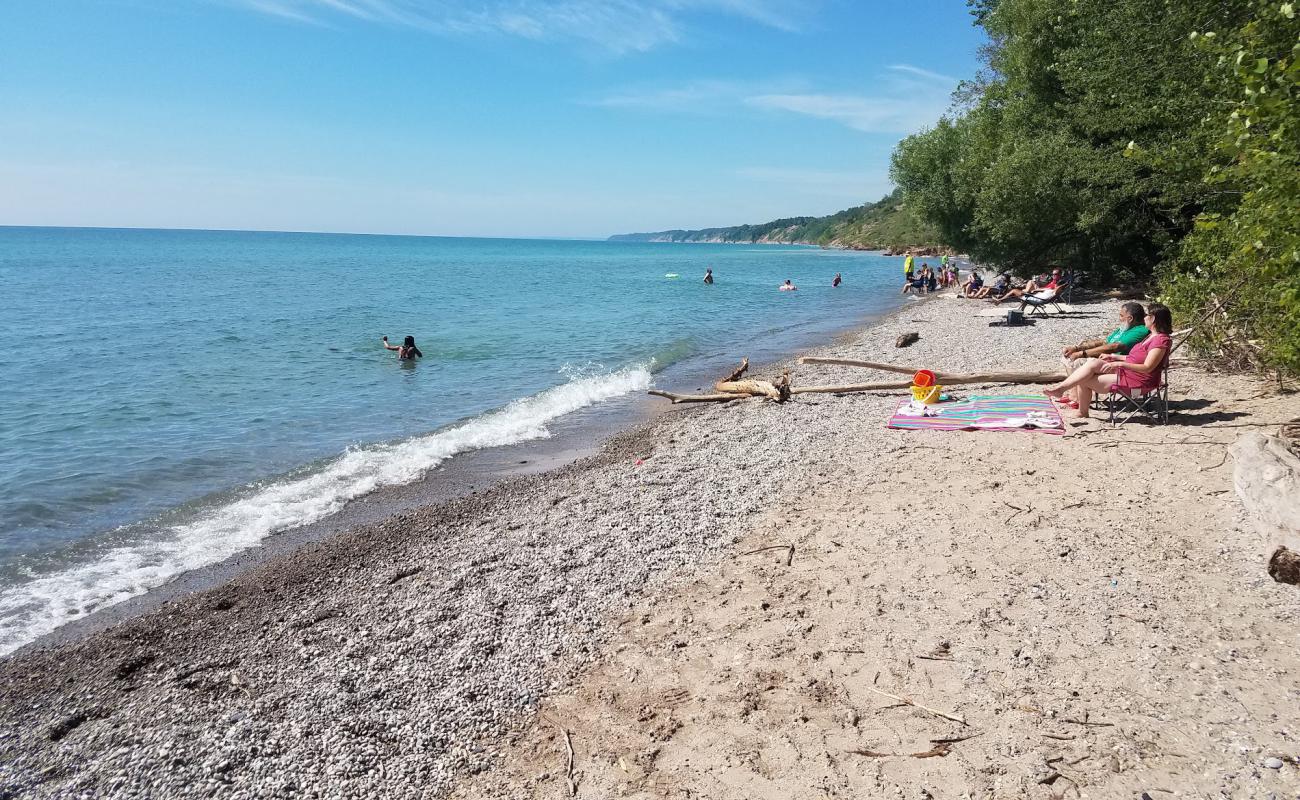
1043, 303, 1174, 419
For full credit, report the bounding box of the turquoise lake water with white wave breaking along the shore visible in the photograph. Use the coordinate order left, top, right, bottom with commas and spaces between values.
0, 228, 901, 653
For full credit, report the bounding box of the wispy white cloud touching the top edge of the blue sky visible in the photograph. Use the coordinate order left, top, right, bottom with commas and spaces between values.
224, 0, 807, 53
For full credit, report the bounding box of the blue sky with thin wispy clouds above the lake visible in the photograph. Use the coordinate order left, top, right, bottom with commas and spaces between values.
0, 0, 982, 237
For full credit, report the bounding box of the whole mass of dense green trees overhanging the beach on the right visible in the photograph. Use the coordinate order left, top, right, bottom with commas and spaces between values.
891, 0, 1300, 376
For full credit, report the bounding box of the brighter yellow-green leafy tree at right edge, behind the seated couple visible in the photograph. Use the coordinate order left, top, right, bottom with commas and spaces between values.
1159, 0, 1300, 376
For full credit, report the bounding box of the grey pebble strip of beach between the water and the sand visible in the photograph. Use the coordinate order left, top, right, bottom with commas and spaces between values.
0, 297, 1300, 797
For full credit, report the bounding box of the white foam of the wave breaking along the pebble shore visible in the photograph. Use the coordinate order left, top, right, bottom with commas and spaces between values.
0, 367, 650, 654
